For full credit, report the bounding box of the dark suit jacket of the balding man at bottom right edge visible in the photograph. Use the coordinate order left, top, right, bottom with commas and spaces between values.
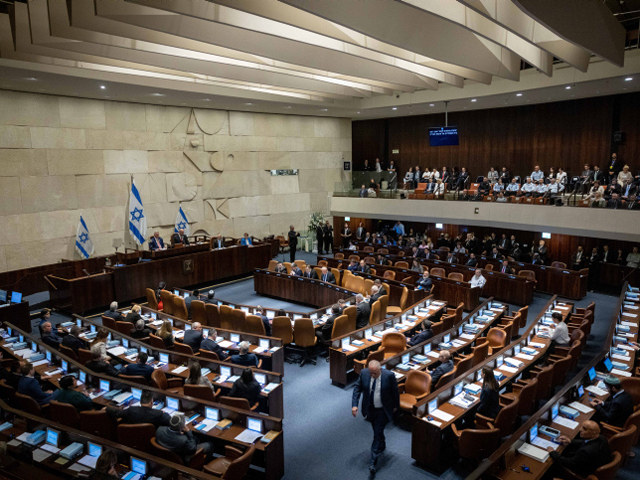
550, 435, 611, 477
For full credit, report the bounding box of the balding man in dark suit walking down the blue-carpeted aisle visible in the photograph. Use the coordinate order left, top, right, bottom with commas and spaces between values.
351, 360, 400, 473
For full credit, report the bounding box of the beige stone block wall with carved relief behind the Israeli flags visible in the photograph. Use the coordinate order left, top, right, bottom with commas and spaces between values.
0, 90, 351, 271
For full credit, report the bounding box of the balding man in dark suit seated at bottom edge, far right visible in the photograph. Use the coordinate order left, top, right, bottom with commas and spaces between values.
547, 420, 611, 478
